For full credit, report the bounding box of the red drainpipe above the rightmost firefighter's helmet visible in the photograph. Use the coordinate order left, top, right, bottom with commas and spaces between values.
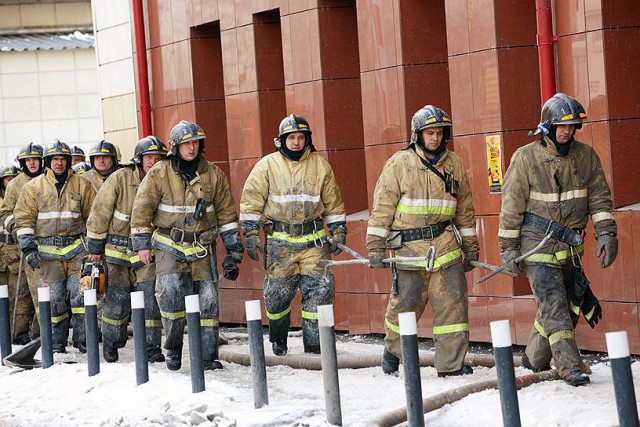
536, 0, 556, 104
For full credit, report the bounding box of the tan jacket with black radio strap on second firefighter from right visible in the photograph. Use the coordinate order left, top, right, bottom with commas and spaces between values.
367, 144, 479, 270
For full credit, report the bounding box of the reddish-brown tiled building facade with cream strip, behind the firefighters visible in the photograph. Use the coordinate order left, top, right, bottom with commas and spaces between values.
94, 0, 640, 353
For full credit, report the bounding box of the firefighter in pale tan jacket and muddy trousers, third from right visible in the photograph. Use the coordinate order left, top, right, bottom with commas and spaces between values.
240, 114, 347, 356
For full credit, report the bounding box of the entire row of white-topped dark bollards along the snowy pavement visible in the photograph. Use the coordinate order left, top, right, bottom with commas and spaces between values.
0, 285, 640, 427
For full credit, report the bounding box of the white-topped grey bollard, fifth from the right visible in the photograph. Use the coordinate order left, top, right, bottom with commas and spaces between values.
244, 300, 269, 409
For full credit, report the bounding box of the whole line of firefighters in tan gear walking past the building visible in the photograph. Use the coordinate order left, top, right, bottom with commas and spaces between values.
0, 93, 618, 386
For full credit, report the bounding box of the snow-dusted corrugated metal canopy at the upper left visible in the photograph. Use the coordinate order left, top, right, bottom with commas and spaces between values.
0, 31, 95, 52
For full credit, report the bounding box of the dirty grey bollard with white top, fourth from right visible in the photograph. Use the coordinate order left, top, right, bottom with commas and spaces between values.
318, 304, 342, 426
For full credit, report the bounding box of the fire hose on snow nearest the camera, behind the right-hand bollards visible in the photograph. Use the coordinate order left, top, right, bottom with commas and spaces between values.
367, 370, 560, 427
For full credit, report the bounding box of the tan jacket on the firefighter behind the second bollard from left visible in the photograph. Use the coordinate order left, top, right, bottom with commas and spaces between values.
13, 168, 95, 260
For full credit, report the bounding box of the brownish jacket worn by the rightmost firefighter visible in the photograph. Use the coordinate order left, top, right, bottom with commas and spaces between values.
498, 136, 616, 265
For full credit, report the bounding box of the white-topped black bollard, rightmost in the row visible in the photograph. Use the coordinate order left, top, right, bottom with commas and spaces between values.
606, 331, 640, 427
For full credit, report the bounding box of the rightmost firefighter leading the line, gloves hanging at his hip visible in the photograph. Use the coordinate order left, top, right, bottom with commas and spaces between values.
498, 93, 618, 386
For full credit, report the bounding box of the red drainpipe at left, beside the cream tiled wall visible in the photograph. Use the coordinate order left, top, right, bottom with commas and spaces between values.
132, 0, 153, 137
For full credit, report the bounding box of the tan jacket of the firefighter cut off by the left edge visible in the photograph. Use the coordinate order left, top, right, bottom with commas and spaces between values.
0, 173, 31, 274
